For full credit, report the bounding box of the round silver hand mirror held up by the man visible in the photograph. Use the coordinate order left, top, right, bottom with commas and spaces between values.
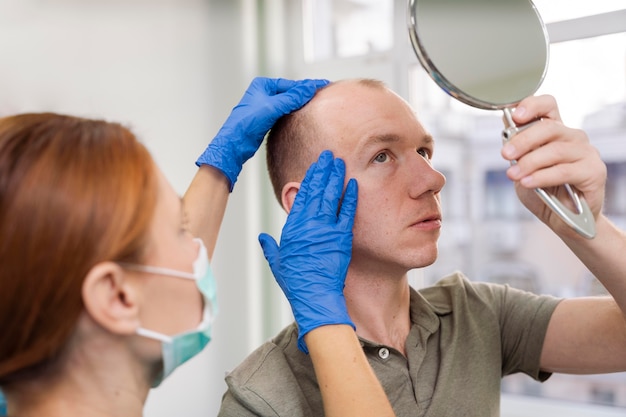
409, 0, 596, 238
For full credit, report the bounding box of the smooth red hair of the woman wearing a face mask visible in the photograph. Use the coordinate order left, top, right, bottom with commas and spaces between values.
0, 113, 157, 385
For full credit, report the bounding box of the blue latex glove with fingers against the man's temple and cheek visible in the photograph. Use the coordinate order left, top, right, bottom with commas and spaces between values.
259, 151, 357, 353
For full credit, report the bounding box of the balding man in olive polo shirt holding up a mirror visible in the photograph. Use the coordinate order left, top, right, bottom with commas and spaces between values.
220, 80, 626, 417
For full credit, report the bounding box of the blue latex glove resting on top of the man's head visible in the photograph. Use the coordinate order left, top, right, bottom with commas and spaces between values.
196, 77, 328, 191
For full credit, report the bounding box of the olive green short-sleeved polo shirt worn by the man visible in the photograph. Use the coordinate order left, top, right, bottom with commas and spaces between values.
219, 273, 559, 417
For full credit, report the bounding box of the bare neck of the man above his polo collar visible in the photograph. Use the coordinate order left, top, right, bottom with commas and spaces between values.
344, 274, 411, 355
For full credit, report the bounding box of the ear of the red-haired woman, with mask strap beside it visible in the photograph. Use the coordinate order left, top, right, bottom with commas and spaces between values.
82, 262, 139, 334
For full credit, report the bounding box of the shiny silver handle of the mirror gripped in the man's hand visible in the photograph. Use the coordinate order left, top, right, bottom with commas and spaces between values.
502, 108, 596, 239
